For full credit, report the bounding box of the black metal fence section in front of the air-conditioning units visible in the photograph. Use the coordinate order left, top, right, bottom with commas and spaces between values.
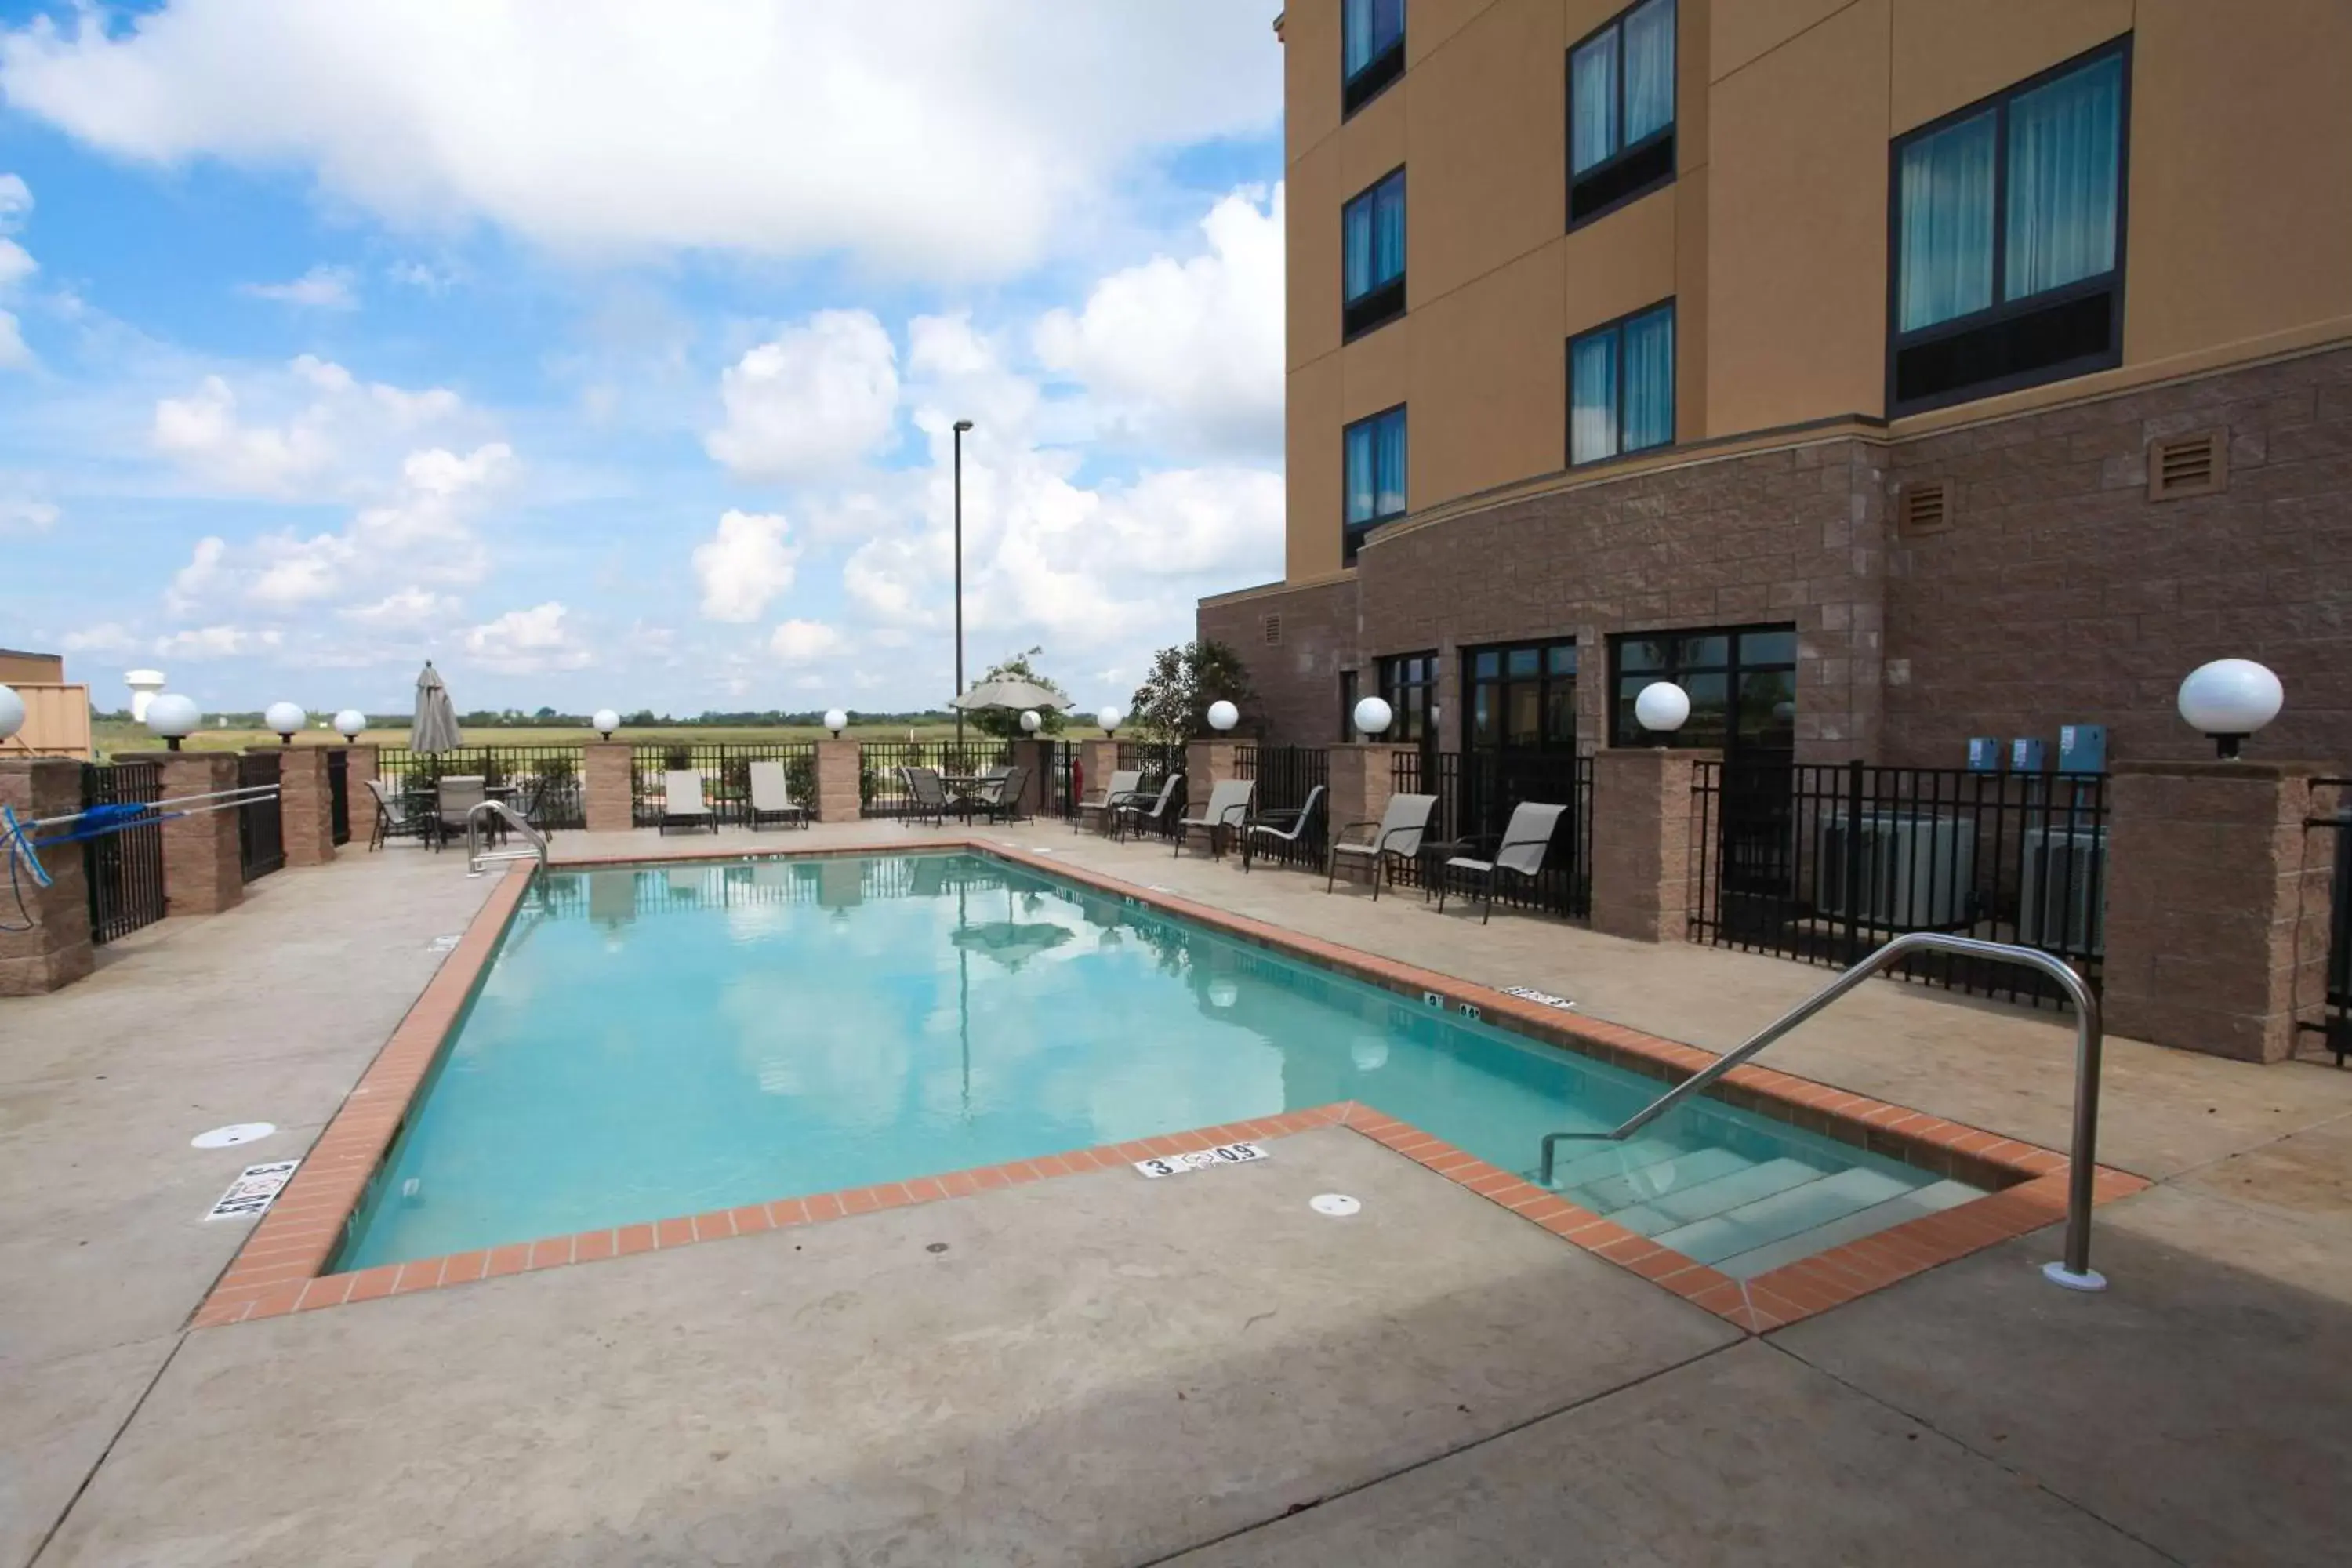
1689, 762, 2107, 1006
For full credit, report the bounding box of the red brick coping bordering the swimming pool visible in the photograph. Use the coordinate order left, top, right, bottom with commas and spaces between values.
193, 834, 2147, 1333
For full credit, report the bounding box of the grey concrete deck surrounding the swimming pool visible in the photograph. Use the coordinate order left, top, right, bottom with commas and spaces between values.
0, 825, 2352, 1566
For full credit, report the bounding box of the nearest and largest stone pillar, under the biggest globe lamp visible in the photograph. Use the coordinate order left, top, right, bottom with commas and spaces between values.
2100, 762, 2338, 1062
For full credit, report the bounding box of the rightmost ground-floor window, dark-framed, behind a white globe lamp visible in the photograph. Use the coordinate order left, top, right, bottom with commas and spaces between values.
1609, 626, 1797, 760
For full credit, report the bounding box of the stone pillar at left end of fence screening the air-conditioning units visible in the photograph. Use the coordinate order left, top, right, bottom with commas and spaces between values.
1592, 746, 1722, 942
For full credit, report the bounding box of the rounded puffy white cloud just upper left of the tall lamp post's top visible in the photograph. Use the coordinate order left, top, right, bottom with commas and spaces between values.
703, 310, 898, 480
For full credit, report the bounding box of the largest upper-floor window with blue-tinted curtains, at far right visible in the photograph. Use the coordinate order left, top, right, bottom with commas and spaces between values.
1886, 40, 2129, 414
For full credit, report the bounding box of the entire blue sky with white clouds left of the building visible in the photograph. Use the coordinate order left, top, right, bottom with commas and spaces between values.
0, 0, 1282, 713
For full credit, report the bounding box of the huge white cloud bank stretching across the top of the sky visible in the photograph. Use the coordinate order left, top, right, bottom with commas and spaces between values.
0, 0, 1282, 278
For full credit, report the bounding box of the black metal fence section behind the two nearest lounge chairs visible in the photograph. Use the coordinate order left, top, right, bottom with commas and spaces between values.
1388, 750, 1592, 919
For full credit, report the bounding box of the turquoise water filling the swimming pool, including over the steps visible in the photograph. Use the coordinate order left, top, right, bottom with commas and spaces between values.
339, 853, 1950, 1267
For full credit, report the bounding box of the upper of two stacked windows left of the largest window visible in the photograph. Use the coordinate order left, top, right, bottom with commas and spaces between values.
1569, 0, 1675, 228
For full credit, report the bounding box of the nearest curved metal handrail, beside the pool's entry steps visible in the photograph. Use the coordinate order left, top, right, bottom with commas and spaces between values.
1541, 931, 2107, 1290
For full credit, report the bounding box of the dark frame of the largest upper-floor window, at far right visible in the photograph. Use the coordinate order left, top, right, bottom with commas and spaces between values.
1886, 33, 2133, 419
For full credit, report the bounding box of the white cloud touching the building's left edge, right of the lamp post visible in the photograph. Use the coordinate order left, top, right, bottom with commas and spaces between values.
1037, 186, 1282, 454
